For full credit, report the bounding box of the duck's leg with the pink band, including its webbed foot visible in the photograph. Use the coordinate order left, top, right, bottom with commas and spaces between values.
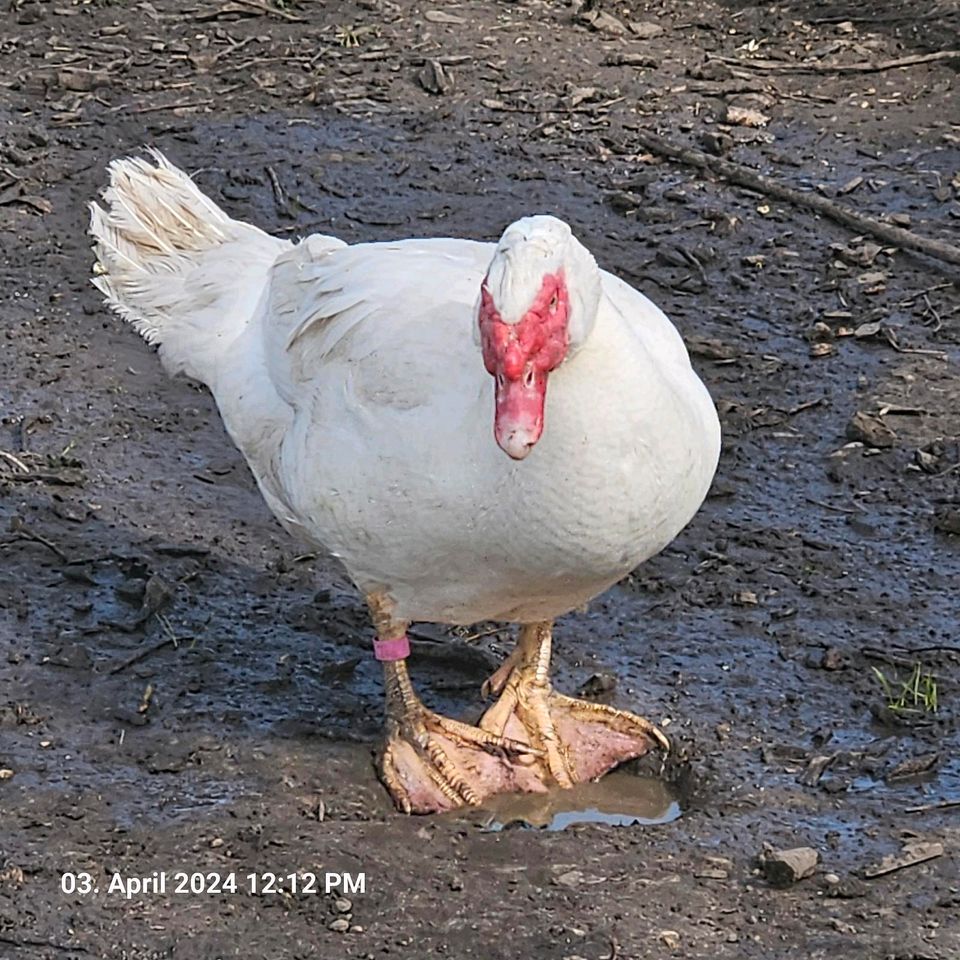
367, 595, 540, 813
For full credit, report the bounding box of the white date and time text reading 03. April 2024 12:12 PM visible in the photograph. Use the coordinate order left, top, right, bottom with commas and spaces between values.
60, 870, 367, 900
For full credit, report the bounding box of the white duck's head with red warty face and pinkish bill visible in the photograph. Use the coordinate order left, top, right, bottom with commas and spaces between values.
477, 216, 600, 460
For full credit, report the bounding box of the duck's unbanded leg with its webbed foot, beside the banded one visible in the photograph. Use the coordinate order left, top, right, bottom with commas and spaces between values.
480, 622, 670, 787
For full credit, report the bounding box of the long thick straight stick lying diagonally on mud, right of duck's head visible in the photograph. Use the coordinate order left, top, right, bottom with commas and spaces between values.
633, 130, 960, 266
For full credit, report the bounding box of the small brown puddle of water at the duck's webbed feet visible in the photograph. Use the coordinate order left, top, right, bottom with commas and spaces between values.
460, 772, 681, 832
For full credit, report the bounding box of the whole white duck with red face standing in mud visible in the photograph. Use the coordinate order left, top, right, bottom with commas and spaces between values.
91, 152, 720, 812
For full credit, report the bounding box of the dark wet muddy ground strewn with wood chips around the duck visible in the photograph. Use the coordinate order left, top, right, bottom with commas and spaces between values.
0, 0, 960, 960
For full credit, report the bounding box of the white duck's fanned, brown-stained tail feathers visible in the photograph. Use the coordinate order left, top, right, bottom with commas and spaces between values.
90, 150, 291, 385
